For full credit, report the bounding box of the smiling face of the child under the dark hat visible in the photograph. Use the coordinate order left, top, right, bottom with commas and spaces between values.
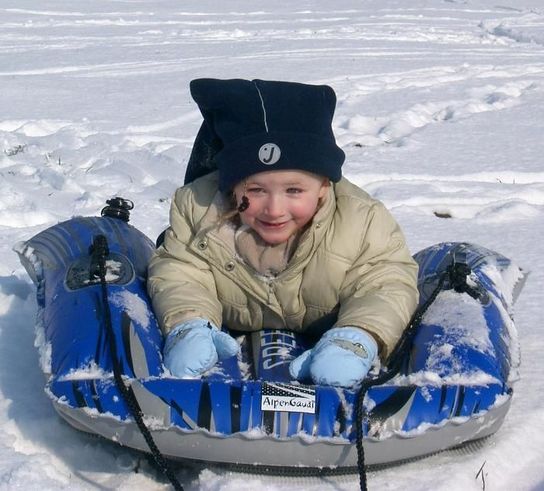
234, 170, 329, 244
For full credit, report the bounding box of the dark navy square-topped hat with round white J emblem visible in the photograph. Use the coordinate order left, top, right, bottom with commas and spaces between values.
186, 78, 345, 191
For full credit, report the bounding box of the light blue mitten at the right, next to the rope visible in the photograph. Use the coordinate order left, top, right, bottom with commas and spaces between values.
289, 327, 378, 387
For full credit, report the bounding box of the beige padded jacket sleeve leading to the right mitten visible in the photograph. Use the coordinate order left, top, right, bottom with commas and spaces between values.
336, 203, 419, 360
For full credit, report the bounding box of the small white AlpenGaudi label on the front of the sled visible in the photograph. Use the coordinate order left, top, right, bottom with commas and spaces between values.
261, 382, 315, 414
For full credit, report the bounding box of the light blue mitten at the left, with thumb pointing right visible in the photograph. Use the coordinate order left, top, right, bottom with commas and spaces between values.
163, 318, 240, 377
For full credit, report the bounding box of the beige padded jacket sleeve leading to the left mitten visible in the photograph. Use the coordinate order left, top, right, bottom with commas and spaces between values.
147, 186, 222, 334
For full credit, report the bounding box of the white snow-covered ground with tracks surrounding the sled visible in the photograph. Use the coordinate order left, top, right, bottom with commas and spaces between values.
0, 0, 544, 491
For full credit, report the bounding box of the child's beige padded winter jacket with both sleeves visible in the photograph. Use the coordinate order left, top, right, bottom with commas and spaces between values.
148, 173, 418, 358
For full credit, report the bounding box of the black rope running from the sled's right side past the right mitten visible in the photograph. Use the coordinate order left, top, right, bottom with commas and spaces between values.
355, 268, 448, 491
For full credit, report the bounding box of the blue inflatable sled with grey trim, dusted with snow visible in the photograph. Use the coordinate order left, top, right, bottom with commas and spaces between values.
16, 203, 523, 469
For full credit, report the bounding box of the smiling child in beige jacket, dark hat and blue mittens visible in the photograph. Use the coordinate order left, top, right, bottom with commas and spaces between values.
148, 79, 418, 387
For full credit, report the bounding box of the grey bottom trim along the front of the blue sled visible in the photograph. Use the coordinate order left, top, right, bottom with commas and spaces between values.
53, 398, 511, 468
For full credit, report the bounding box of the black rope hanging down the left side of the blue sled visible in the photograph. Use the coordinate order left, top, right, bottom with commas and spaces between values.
90, 235, 183, 491
